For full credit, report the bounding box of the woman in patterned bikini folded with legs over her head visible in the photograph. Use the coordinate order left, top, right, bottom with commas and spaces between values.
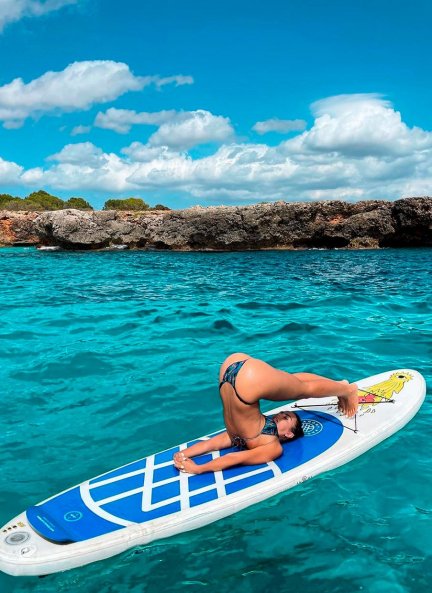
174, 352, 358, 474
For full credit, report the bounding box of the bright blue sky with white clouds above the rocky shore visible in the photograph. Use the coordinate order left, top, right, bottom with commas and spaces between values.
0, 0, 432, 207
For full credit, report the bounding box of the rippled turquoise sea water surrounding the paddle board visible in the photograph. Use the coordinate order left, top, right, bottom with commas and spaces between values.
0, 249, 432, 593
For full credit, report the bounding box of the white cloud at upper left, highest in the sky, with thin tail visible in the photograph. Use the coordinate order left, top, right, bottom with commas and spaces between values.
0, 60, 192, 128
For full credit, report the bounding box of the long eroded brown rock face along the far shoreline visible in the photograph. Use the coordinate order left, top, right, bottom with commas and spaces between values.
0, 197, 432, 251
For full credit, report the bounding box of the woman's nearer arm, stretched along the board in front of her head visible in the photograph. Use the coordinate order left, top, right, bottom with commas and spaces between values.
174, 440, 283, 474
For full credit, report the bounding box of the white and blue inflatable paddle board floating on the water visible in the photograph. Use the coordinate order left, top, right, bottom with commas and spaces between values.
0, 369, 426, 575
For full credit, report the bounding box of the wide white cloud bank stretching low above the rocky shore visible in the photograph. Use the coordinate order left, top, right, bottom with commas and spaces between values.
6, 95, 432, 203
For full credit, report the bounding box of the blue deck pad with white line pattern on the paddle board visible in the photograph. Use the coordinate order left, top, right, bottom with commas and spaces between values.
27, 409, 343, 543
